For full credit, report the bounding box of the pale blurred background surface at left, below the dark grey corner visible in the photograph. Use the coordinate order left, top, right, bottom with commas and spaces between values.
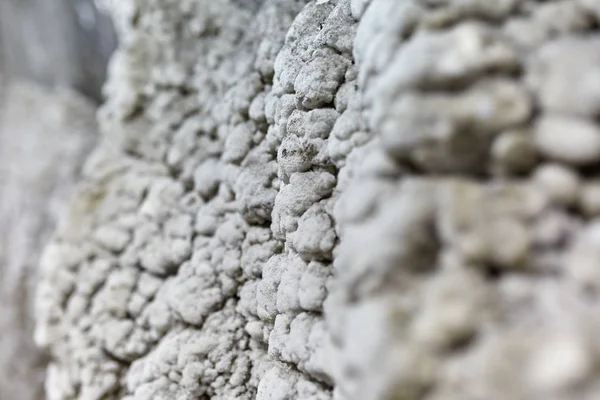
0, 81, 95, 400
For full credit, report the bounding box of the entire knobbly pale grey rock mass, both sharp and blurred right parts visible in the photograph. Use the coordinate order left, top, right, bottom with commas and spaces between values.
36, 0, 600, 400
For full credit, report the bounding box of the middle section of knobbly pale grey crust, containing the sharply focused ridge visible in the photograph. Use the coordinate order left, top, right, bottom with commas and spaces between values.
36, 0, 360, 400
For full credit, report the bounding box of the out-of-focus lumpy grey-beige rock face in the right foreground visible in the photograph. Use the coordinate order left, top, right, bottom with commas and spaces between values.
327, 0, 600, 400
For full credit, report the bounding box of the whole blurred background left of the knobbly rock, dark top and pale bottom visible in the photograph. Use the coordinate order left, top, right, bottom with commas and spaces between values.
0, 0, 116, 400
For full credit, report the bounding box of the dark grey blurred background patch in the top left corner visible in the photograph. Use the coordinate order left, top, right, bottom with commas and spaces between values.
0, 0, 116, 100
